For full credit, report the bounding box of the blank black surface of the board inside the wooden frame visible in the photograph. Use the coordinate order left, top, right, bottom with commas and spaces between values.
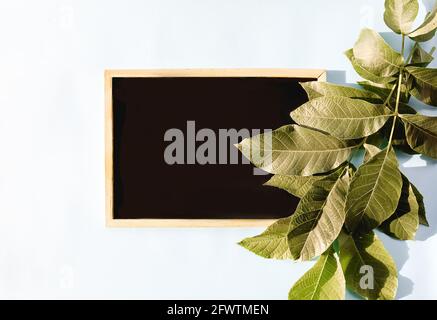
111, 71, 317, 224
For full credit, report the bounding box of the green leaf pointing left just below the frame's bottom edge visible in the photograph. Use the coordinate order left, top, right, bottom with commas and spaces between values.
239, 217, 291, 259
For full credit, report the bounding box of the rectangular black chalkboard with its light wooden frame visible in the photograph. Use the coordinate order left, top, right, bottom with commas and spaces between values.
105, 69, 325, 227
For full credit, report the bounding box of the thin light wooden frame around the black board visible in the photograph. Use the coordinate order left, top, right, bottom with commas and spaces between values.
105, 69, 326, 227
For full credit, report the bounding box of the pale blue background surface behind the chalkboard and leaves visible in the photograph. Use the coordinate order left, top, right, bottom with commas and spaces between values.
0, 0, 437, 299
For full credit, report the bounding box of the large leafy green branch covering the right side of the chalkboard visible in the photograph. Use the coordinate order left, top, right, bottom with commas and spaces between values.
238, 0, 437, 299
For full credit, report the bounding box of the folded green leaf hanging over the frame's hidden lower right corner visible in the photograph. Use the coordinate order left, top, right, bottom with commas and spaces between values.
288, 170, 349, 260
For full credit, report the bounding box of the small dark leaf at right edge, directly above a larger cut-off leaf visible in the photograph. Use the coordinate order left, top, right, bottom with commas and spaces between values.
406, 66, 437, 106
